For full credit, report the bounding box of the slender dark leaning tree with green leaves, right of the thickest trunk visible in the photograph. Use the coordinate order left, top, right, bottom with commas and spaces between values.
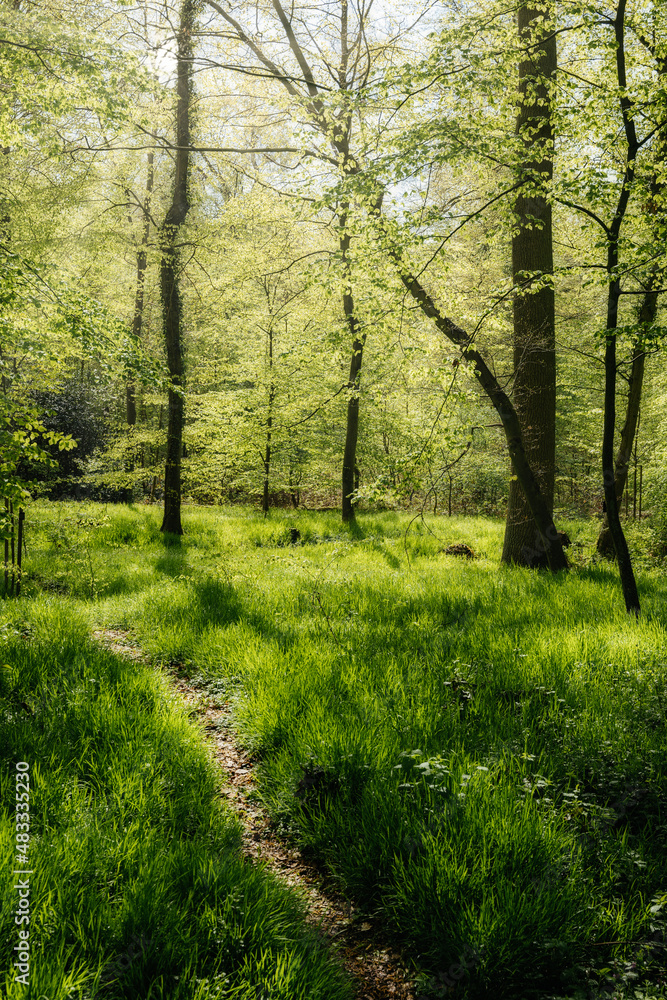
557, 0, 665, 614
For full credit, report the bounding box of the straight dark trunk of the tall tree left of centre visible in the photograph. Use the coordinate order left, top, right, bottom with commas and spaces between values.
160, 0, 196, 535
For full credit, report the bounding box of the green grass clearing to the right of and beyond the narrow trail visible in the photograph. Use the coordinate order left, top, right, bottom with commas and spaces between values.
9, 505, 667, 998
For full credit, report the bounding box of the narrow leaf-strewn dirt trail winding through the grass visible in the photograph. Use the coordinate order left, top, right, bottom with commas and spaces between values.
92, 628, 415, 1000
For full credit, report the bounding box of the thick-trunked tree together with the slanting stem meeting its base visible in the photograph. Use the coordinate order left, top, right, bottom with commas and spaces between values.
350, 6, 567, 571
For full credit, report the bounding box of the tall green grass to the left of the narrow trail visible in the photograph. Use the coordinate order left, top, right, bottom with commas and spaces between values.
0, 597, 349, 1000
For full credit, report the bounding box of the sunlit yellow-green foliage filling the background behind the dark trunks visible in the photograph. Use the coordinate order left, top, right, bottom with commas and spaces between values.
2, 3, 664, 540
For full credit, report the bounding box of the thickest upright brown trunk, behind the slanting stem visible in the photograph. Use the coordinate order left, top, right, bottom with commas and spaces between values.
502, 0, 556, 566
